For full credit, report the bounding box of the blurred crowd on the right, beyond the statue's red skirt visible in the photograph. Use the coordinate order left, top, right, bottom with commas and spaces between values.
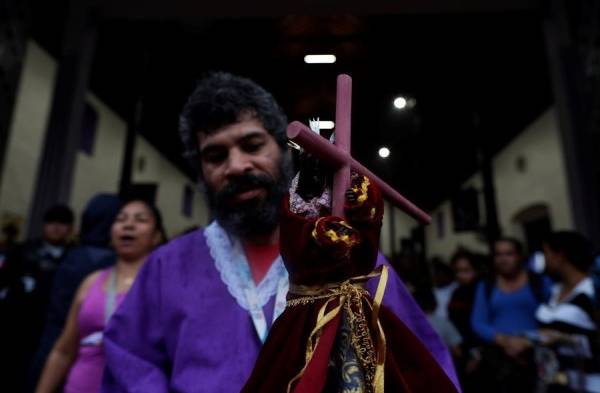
397, 231, 600, 393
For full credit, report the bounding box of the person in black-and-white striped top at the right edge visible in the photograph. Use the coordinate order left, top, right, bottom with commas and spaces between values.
536, 231, 600, 392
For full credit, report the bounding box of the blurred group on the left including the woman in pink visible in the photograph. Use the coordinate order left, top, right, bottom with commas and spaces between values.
0, 194, 166, 393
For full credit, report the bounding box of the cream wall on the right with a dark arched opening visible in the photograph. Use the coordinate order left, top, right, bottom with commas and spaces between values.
425, 108, 573, 258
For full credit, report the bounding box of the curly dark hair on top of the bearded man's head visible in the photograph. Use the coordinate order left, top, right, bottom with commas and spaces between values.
179, 72, 287, 169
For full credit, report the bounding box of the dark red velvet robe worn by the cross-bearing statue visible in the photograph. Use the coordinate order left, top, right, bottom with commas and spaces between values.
242, 178, 457, 393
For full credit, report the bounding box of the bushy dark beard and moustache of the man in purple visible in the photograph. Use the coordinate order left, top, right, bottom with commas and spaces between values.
206, 155, 292, 238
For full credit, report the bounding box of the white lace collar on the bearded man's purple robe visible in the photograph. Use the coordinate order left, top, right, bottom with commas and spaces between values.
204, 221, 288, 310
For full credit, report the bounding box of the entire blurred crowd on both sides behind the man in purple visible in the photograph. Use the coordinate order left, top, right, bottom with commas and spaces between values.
0, 194, 600, 393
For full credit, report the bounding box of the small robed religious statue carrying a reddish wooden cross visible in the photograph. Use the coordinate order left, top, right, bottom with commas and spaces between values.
242, 75, 459, 393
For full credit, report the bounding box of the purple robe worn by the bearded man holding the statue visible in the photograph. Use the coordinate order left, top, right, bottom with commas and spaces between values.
102, 230, 458, 393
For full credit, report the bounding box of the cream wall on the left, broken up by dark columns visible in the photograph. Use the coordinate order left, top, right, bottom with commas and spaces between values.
0, 41, 208, 240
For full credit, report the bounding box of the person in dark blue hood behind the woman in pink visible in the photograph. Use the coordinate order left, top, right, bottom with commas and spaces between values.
26, 194, 121, 392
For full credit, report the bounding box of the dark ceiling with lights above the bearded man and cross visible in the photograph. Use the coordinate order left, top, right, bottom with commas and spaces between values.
28, 0, 552, 208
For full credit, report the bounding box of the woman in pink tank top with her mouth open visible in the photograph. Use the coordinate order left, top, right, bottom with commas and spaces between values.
35, 200, 164, 393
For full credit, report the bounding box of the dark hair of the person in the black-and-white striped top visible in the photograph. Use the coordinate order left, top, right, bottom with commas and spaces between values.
544, 231, 594, 273
